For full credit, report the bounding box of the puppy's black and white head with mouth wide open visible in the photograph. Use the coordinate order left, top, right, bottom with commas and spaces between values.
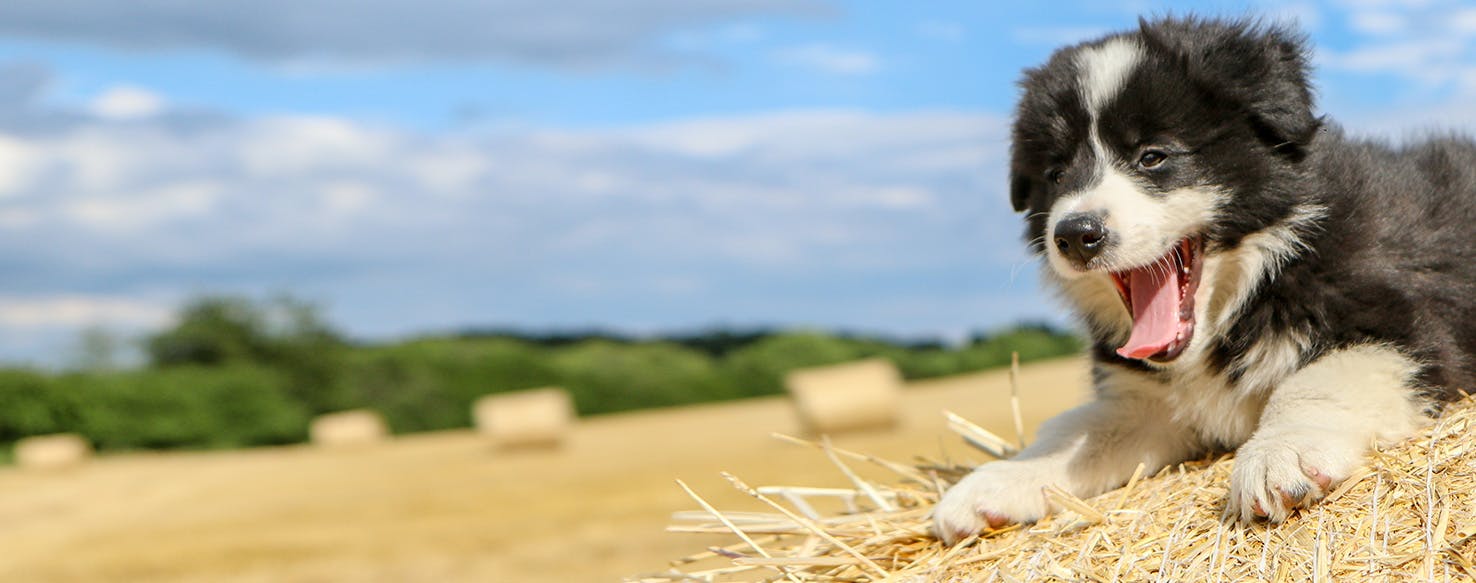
1010, 19, 1320, 362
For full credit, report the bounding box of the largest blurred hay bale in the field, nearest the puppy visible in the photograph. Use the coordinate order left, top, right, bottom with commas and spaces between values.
784, 359, 902, 434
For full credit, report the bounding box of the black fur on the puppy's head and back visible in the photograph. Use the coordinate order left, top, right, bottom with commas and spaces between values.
1010, 18, 1476, 399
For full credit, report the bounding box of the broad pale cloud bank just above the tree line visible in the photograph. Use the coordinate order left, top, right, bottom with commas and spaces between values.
0, 104, 1033, 357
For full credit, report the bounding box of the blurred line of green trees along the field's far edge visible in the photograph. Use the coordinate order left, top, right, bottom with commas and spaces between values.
0, 297, 1080, 450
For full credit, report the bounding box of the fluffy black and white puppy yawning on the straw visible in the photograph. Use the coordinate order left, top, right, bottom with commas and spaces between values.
934, 18, 1476, 542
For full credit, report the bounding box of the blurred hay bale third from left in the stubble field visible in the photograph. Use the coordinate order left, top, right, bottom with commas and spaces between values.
472, 387, 574, 449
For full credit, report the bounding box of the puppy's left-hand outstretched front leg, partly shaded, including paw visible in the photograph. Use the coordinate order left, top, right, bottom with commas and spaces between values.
933, 386, 1197, 543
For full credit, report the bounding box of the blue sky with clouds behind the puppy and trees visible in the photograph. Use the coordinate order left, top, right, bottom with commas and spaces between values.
0, 0, 1476, 365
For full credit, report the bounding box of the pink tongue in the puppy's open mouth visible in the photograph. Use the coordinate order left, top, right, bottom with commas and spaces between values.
1117, 263, 1179, 359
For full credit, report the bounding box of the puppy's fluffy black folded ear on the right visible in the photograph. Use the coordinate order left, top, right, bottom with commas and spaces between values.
1139, 18, 1322, 156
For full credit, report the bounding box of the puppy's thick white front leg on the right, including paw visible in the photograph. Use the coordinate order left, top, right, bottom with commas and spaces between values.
1227, 345, 1424, 522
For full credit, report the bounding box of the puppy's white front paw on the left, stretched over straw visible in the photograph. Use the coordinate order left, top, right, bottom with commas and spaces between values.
933, 460, 1064, 545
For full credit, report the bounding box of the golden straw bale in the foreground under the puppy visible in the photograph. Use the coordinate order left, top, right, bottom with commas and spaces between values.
649, 399, 1476, 582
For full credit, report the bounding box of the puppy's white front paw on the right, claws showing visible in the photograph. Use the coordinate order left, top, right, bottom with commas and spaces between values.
1225, 430, 1362, 522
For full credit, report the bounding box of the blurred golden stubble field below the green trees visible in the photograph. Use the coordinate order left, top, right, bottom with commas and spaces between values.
0, 359, 1086, 582
